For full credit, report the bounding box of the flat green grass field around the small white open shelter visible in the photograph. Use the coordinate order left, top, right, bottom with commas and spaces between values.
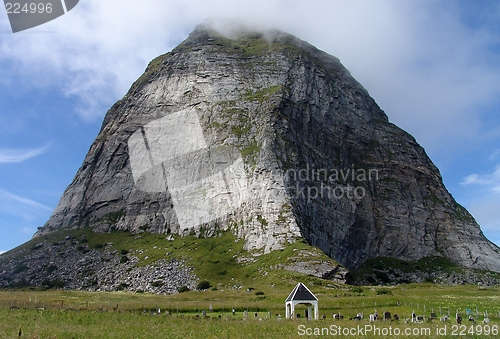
0, 283, 500, 339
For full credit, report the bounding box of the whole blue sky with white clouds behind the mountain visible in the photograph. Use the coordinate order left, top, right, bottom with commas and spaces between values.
0, 0, 500, 251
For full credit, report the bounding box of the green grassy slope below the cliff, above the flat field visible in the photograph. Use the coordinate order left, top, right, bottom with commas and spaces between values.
0, 228, 344, 289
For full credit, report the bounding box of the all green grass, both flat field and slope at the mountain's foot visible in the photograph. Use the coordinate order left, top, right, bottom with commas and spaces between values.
0, 229, 500, 339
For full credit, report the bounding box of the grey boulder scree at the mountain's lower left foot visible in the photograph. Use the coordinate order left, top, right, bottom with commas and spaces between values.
0, 237, 198, 294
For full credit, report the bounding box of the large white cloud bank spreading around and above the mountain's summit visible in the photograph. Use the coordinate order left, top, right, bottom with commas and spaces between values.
0, 0, 500, 155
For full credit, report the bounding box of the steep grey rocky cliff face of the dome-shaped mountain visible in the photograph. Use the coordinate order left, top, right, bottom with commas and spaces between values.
37, 26, 500, 271
